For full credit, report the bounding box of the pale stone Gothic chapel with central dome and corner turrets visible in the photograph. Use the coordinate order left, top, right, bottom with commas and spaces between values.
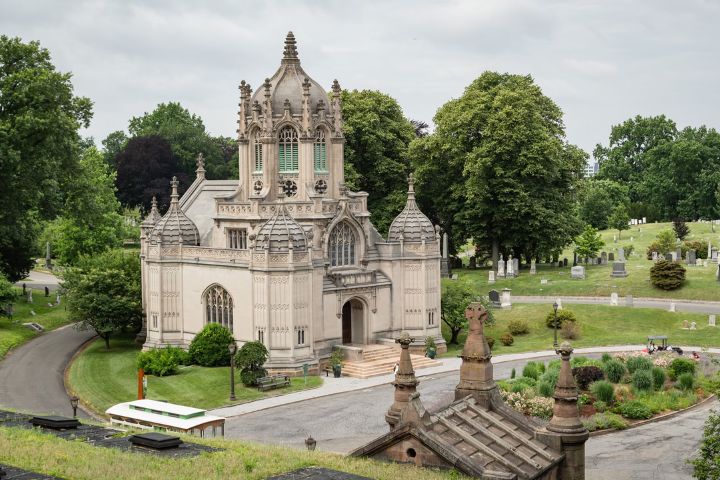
141, 32, 445, 373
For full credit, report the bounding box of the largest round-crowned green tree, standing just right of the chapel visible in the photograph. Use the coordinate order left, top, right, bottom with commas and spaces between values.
410, 72, 587, 264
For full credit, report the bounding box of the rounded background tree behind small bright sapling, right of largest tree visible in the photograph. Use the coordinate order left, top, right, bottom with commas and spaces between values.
580, 178, 630, 230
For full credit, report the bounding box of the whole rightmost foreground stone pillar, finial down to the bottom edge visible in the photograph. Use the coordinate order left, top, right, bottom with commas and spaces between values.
547, 342, 590, 480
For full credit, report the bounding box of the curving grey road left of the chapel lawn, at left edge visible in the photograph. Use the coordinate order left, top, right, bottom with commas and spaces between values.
0, 325, 95, 417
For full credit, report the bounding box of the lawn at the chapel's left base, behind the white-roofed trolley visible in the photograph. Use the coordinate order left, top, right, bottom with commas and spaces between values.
69, 337, 322, 412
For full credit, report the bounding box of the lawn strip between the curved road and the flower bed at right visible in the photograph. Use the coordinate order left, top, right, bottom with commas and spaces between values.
443, 304, 720, 356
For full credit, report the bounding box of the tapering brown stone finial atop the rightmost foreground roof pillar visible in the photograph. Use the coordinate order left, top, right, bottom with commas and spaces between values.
547, 342, 587, 434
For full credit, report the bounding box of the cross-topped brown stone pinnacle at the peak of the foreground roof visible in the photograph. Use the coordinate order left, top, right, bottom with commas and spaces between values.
455, 302, 497, 408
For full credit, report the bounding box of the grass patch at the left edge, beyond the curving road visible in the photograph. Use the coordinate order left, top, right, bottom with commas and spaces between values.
0, 288, 69, 359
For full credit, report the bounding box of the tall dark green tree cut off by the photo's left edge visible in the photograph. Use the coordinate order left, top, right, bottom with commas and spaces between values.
0, 35, 92, 280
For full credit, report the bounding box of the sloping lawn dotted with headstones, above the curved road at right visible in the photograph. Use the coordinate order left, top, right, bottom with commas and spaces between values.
456, 223, 720, 301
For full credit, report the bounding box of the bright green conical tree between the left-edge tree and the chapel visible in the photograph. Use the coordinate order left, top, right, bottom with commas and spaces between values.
43, 147, 125, 265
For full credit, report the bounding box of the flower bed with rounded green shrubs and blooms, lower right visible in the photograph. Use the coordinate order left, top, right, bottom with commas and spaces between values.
498, 352, 720, 431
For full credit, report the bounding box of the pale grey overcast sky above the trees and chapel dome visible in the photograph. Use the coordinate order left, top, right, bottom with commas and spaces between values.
0, 0, 720, 161
